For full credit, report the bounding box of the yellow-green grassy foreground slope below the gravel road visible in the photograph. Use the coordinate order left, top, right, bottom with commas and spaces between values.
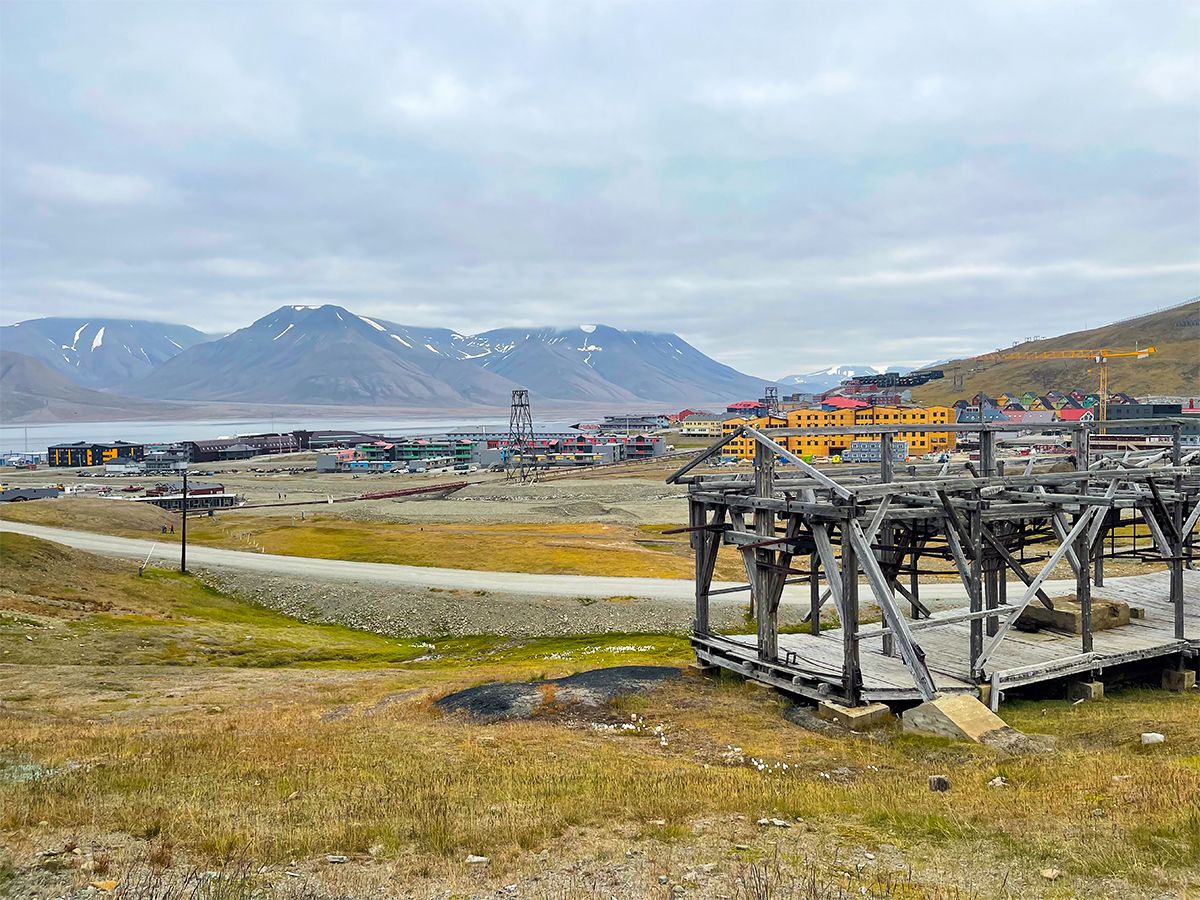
0, 534, 1200, 898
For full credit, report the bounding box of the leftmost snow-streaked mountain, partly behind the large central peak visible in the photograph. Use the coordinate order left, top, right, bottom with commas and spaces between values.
0, 318, 210, 388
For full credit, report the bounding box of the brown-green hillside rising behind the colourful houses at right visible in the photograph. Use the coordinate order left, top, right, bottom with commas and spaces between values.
913, 299, 1200, 403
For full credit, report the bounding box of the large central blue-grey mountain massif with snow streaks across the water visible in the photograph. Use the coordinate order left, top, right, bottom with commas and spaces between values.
125, 306, 767, 406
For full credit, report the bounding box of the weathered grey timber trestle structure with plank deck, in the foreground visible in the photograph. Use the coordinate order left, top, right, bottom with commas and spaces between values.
667, 419, 1200, 708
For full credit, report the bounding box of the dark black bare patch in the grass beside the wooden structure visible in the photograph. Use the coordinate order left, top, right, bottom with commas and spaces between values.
436, 666, 683, 722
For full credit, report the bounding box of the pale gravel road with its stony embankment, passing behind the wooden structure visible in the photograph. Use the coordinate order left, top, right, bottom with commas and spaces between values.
0, 521, 1121, 636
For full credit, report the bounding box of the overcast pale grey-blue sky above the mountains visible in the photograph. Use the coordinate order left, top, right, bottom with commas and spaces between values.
0, 0, 1200, 377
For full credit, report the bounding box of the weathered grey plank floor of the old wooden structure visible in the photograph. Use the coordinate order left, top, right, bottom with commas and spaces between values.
696, 571, 1200, 701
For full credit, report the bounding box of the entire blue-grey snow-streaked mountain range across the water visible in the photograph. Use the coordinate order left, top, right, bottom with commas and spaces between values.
0, 305, 770, 418
